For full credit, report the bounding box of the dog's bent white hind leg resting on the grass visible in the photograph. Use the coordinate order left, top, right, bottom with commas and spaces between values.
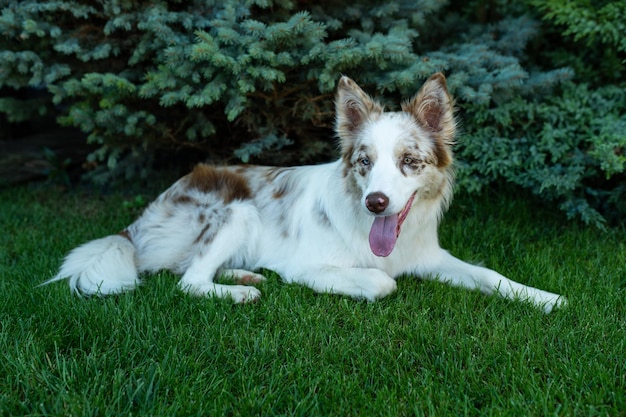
178, 206, 261, 303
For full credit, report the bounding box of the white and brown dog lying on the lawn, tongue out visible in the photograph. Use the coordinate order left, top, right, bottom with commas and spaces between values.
42, 73, 566, 313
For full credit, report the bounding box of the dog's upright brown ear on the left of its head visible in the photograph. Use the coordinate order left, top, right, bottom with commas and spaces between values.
335, 76, 383, 139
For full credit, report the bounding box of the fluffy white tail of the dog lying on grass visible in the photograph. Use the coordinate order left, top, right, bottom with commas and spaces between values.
41, 235, 139, 295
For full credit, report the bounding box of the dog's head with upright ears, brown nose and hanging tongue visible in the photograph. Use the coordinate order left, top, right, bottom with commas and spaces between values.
336, 73, 456, 256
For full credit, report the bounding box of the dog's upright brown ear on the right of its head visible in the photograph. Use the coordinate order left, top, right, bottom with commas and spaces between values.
402, 72, 456, 167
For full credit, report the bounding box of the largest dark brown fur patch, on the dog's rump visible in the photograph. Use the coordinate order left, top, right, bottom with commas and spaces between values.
185, 164, 252, 204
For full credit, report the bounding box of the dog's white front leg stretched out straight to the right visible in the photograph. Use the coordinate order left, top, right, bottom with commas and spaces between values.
420, 249, 567, 313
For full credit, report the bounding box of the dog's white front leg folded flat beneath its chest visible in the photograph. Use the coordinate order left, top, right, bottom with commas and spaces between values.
285, 266, 396, 301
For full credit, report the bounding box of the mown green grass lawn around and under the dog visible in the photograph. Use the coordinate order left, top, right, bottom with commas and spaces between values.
0, 186, 626, 416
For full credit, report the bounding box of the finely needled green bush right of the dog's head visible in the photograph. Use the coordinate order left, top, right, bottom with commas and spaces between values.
458, 83, 626, 227
